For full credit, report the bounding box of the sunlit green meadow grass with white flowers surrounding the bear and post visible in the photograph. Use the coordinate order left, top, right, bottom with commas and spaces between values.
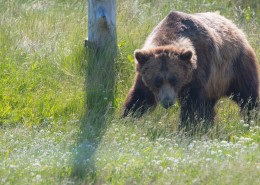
0, 0, 260, 185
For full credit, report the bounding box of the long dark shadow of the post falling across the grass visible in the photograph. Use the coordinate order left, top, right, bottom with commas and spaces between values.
72, 38, 116, 184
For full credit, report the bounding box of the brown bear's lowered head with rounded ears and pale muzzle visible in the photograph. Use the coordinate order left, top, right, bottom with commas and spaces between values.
135, 45, 197, 108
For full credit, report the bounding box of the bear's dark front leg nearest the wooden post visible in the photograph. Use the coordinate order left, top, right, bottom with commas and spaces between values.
122, 76, 156, 117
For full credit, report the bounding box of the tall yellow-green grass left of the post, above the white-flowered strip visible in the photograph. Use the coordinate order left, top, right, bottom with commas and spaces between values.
0, 1, 86, 125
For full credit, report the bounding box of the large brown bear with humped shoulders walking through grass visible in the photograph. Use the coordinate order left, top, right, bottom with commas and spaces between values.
123, 11, 259, 128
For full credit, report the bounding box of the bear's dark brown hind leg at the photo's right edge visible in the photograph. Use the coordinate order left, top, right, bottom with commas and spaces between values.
226, 52, 260, 122
